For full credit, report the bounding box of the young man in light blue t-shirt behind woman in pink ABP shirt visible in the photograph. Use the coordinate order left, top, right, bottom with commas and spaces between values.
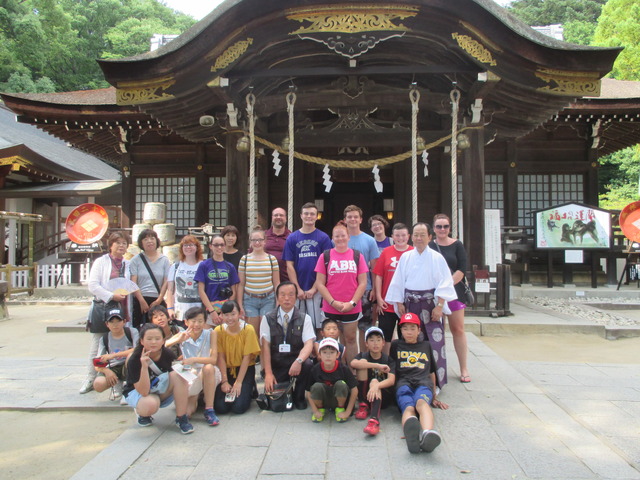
344, 205, 380, 345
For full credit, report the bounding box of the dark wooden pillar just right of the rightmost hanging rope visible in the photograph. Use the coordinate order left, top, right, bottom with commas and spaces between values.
462, 128, 484, 266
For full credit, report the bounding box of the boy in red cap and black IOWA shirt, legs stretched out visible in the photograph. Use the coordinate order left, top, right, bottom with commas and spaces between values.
389, 313, 449, 453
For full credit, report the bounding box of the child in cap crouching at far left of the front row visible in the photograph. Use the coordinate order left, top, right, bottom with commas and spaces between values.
93, 308, 138, 400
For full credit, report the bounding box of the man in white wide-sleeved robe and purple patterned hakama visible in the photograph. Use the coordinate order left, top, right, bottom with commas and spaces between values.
385, 222, 458, 388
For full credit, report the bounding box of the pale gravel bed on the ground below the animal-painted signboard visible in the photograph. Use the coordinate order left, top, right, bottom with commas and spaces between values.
520, 297, 640, 327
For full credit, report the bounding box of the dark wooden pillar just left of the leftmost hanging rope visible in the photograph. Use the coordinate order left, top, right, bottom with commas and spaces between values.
226, 132, 249, 251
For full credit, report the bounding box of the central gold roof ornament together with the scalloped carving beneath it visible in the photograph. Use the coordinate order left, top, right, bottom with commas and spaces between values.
287, 5, 418, 58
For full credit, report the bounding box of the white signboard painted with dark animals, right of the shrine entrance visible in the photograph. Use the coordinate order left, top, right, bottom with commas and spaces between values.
535, 203, 611, 250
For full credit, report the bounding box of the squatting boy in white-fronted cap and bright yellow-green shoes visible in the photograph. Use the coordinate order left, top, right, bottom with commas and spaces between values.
306, 338, 358, 423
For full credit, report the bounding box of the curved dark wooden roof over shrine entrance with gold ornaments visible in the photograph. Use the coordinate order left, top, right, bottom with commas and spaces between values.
95, 0, 620, 146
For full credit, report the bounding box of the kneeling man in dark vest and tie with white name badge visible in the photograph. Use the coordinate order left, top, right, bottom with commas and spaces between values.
260, 282, 316, 410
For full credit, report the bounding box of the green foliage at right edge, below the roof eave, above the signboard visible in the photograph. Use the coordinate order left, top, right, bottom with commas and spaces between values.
599, 145, 640, 210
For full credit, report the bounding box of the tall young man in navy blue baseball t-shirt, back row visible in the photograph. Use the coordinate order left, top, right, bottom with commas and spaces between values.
282, 202, 332, 330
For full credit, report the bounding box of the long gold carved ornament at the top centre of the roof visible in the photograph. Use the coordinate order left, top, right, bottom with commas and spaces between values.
287, 5, 418, 35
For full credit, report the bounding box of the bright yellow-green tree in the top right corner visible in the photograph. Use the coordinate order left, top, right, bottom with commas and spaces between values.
593, 0, 640, 80
